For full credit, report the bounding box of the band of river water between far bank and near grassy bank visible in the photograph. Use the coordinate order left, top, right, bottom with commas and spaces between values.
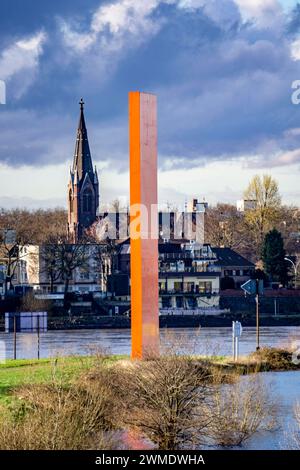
0, 327, 300, 359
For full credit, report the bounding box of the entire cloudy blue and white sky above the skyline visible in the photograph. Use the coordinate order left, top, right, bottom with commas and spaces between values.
0, 0, 300, 207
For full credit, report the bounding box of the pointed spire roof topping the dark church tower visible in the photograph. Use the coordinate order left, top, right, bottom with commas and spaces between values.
72, 98, 94, 181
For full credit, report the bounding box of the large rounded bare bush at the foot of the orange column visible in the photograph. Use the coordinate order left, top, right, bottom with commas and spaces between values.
120, 354, 214, 450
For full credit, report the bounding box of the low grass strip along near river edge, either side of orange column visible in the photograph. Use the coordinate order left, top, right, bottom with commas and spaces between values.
0, 348, 300, 403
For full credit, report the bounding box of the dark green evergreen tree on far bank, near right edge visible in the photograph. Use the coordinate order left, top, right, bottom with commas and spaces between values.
262, 228, 288, 285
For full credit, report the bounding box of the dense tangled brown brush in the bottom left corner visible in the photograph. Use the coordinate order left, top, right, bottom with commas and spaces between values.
0, 362, 117, 450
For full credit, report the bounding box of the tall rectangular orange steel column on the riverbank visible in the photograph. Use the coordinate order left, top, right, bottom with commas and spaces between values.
129, 91, 159, 359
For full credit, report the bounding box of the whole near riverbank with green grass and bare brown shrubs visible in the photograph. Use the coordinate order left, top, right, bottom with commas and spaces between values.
0, 349, 300, 450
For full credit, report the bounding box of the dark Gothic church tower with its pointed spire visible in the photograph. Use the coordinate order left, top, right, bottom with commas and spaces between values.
68, 98, 99, 242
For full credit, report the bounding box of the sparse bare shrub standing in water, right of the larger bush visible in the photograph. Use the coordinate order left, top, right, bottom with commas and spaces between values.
207, 374, 276, 447
